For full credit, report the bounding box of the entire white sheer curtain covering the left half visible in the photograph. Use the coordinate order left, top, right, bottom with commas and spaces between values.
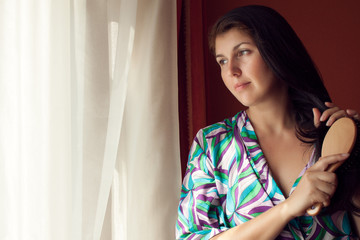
0, 0, 180, 240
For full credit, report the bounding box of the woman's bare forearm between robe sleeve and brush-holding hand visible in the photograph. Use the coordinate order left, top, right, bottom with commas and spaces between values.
211, 201, 293, 240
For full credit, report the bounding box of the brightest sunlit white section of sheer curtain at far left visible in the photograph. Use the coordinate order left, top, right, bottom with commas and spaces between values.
0, 1, 73, 239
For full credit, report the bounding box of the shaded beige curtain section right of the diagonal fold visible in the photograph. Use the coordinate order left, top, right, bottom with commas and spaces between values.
112, 0, 181, 239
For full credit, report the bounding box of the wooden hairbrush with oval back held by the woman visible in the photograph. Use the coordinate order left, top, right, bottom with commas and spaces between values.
306, 117, 359, 216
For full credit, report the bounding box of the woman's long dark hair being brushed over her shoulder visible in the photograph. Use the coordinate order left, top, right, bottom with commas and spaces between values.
209, 5, 360, 213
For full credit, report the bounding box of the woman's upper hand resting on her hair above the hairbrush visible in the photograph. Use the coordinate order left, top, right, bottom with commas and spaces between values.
313, 102, 360, 127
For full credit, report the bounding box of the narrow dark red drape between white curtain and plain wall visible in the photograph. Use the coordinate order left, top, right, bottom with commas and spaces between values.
177, 0, 208, 176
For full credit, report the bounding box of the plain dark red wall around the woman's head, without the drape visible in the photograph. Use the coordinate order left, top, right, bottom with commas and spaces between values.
203, 0, 360, 124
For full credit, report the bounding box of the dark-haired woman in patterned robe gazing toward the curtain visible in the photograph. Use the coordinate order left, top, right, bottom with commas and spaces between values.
176, 6, 359, 240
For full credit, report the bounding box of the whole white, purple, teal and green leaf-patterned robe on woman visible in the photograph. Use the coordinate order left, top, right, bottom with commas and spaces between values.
176, 111, 353, 239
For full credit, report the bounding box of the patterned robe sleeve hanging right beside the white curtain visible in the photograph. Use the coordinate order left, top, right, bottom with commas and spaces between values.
176, 131, 227, 239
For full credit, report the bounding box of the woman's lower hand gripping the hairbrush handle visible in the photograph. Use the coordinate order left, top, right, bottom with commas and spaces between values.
286, 154, 349, 217
